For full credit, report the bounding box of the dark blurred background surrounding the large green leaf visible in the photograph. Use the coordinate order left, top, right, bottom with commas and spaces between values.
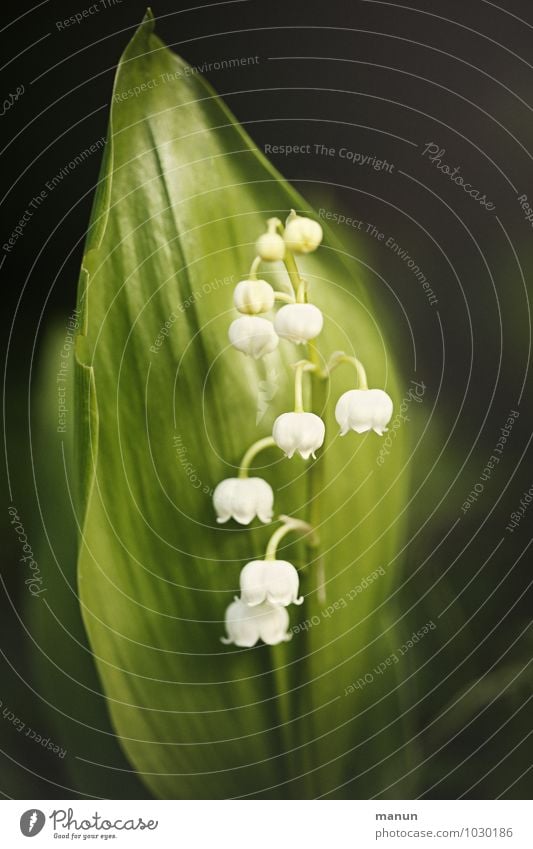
0, 0, 533, 798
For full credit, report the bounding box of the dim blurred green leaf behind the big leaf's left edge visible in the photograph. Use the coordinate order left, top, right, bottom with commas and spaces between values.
28, 322, 150, 799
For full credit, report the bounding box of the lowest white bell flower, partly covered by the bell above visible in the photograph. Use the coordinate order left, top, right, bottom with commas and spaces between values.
221, 598, 291, 648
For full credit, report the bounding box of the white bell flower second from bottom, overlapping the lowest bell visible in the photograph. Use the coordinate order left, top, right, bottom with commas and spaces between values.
240, 560, 303, 607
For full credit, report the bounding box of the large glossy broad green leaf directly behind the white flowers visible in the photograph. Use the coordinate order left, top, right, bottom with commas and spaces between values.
72, 9, 410, 798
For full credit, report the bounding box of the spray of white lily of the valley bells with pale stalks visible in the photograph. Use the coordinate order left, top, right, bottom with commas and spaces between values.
213, 210, 393, 647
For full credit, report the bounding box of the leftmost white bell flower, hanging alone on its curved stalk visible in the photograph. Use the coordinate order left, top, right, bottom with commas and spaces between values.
213, 478, 274, 525
